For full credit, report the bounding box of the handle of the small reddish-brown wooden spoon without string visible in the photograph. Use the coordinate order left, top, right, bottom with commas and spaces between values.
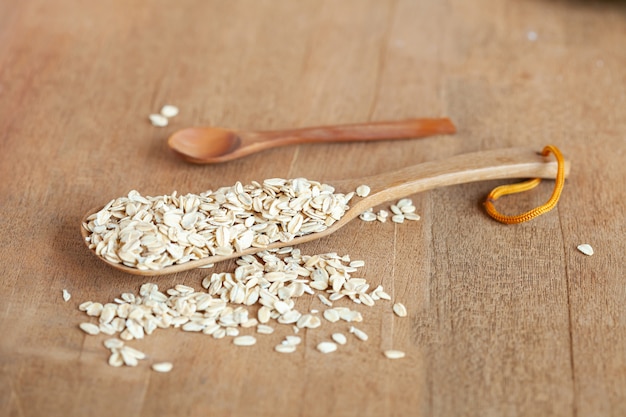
253, 118, 456, 147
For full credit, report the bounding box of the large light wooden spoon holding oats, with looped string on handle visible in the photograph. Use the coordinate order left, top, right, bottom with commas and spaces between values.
81, 148, 569, 276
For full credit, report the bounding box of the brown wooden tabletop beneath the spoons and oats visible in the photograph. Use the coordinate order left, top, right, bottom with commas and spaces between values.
0, 0, 626, 416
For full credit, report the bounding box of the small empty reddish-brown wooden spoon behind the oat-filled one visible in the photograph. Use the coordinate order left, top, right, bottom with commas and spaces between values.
167, 118, 456, 164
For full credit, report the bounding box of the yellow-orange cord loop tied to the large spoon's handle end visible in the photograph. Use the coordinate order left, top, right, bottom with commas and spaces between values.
485, 145, 565, 224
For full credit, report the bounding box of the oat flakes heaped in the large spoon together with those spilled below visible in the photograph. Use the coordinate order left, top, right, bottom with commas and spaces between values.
78, 178, 419, 372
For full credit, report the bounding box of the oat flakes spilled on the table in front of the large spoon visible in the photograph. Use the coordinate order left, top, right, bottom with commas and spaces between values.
79, 247, 407, 372
